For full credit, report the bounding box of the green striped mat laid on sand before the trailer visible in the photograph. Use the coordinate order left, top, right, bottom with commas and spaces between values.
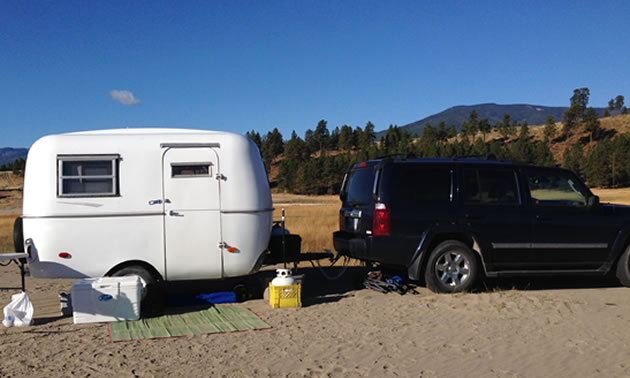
108, 306, 271, 342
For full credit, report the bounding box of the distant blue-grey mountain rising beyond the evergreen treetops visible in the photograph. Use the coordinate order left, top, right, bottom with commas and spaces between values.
377, 103, 604, 139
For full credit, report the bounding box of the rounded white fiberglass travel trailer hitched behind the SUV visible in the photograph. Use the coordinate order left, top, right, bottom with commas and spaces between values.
22, 129, 272, 288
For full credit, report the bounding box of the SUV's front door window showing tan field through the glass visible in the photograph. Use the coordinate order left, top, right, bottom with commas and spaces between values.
526, 170, 588, 206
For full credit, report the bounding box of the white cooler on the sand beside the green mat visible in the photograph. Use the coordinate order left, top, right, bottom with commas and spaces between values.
71, 276, 142, 324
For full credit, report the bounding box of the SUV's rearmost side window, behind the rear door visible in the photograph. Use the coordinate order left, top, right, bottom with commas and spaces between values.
388, 163, 453, 206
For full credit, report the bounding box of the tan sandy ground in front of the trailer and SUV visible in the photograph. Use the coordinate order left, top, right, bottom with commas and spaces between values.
0, 265, 630, 377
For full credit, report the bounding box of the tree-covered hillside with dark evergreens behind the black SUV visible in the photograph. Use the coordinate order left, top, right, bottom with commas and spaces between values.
247, 88, 630, 194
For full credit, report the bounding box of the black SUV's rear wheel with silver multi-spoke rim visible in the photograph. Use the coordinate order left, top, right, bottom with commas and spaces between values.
424, 240, 479, 293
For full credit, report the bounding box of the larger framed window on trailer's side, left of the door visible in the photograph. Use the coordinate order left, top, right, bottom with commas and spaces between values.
57, 155, 120, 197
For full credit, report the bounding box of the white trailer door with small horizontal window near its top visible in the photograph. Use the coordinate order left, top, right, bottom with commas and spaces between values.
163, 146, 223, 280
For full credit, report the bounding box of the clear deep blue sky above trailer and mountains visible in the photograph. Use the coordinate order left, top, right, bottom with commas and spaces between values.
0, 0, 630, 147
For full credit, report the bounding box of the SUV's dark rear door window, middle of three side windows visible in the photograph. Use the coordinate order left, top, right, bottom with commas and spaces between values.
464, 168, 520, 205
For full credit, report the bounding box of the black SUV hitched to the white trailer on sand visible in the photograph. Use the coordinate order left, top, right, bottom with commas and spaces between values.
333, 158, 630, 292
